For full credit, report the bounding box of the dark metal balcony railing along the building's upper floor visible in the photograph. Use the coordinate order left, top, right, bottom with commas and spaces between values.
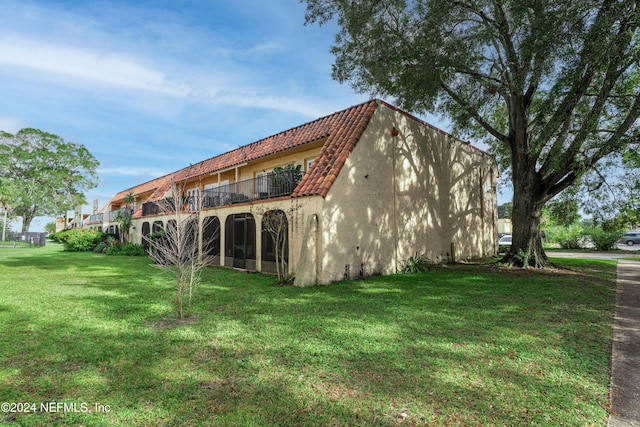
142, 170, 302, 216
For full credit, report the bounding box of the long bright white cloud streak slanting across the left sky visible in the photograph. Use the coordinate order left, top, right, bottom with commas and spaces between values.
0, 36, 340, 117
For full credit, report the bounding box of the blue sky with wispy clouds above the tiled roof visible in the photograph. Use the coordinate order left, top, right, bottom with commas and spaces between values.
0, 0, 490, 231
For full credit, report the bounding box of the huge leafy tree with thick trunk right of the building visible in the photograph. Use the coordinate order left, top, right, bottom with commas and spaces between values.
306, 0, 640, 267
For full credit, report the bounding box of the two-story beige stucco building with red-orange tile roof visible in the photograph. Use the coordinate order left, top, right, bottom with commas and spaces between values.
86, 100, 498, 286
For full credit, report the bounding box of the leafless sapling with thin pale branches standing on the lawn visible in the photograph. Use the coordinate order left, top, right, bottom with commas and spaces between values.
144, 182, 206, 319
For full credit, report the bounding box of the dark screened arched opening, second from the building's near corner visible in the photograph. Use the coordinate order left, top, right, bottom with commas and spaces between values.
224, 213, 256, 270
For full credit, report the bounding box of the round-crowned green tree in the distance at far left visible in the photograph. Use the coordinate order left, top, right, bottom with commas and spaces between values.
0, 128, 98, 232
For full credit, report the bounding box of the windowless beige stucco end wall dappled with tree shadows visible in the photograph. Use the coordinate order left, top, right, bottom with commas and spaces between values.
318, 105, 497, 283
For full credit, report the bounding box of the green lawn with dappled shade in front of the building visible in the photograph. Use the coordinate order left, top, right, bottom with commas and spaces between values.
0, 245, 616, 426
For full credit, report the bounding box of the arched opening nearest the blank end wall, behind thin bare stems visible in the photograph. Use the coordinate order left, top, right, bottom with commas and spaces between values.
261, 210, 289, 277
